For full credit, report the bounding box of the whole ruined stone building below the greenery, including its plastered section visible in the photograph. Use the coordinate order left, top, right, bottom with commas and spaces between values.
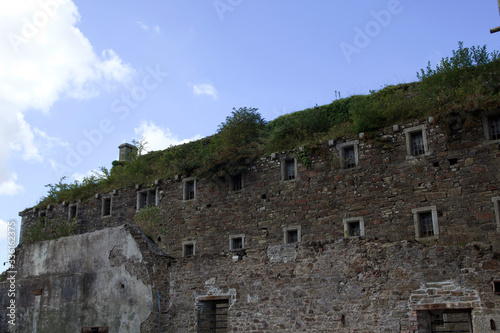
0, 115, 500, 332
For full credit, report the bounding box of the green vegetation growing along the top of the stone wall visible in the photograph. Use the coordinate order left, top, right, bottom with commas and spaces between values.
39, 43, 500, 208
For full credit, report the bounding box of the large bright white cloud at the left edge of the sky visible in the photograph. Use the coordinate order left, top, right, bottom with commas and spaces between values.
0, 0, 133, 195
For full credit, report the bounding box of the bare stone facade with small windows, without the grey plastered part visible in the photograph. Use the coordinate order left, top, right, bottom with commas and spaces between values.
5, 121, 500, 332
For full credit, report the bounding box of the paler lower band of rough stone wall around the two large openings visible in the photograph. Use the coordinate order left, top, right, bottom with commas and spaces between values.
170, 238, 500, 332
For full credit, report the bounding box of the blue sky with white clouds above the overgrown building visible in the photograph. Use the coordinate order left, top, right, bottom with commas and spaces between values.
0, 0, 500, 270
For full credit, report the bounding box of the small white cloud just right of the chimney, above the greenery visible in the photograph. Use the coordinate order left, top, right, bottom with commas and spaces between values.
134, 120, 201, 151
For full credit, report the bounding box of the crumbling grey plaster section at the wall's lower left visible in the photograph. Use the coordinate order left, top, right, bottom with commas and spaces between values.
19, 226, 153, 332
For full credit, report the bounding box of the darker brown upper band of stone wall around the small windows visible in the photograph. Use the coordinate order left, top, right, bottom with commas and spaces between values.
18, 119, 500, 257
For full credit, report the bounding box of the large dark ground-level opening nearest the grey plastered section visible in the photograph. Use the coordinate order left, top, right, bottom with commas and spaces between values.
198, 300, 229, 333
